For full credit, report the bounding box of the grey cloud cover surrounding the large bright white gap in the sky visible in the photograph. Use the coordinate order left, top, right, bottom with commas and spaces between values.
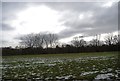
2, 2, 118, 46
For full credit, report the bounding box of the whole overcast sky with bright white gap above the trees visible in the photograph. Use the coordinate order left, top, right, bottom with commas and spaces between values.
0, 1, 118, 46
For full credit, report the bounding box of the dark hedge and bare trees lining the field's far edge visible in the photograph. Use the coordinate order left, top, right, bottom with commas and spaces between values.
2, 33, 120, 56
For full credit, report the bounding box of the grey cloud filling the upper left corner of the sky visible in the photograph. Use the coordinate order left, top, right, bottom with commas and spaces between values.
2, 2, 28, 22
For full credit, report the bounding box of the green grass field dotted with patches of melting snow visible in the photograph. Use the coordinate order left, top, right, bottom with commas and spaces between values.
2, 52, 118, 80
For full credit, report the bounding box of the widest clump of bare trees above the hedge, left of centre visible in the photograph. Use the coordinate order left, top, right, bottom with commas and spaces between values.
20, 33, 58, 48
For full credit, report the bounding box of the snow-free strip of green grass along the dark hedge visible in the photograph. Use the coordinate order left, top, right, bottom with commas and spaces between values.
2, 52, 118, 58
